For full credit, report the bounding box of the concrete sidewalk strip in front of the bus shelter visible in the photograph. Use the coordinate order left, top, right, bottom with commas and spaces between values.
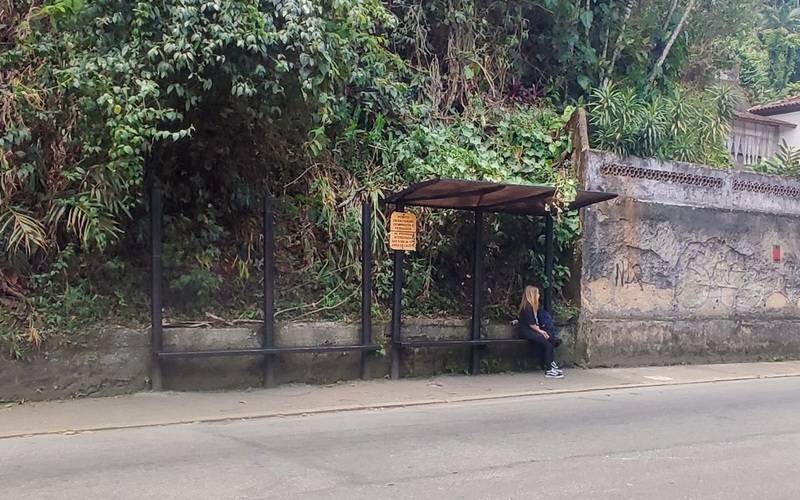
0, 361, 800, 439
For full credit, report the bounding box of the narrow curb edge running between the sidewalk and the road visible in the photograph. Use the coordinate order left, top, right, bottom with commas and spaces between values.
0, 373, 800, 440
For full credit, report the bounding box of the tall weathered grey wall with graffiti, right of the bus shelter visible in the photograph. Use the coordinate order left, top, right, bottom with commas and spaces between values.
580, 151, 800, 365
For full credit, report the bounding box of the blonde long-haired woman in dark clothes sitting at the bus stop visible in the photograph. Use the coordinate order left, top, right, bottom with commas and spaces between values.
517, 286, 564, 378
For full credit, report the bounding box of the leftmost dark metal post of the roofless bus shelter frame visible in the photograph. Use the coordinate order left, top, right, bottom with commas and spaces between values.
150, 187, 164, 391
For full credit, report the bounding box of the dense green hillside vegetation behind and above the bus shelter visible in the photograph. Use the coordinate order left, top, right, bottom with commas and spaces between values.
0, 0, 798, 357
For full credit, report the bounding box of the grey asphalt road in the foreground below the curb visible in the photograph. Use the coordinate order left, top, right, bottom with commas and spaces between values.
0, 378, 800, 500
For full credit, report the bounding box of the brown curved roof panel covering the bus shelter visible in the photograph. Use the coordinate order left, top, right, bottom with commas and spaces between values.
385, 179, 617, 215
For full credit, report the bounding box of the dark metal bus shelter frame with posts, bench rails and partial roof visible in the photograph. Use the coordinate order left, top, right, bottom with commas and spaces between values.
150, 179, 616, 390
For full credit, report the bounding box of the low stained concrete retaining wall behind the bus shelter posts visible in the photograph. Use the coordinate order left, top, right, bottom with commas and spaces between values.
0, 319, 582, 401
